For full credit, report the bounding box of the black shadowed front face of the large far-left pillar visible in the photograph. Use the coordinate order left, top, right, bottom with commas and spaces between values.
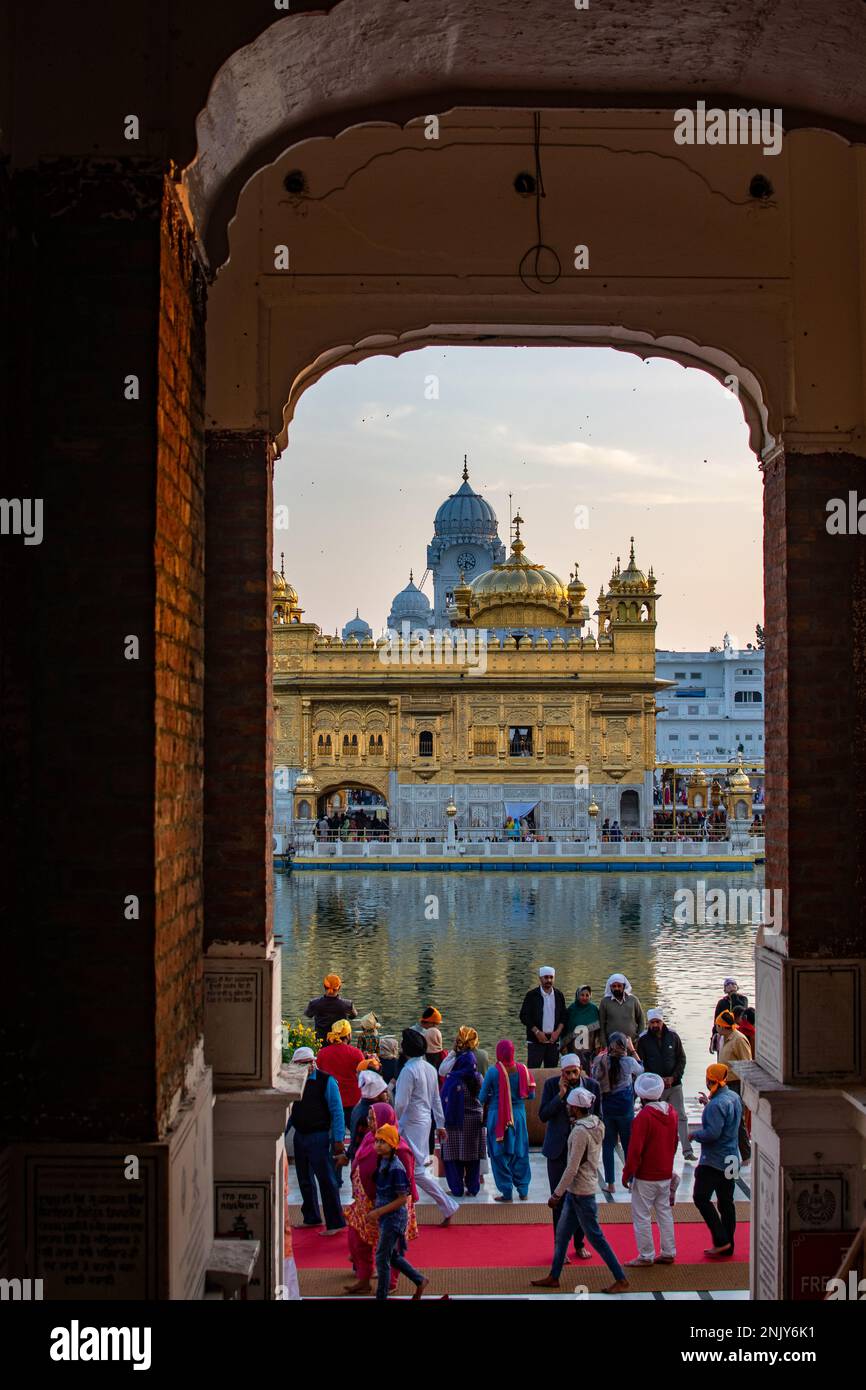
0, 161, 163, 1140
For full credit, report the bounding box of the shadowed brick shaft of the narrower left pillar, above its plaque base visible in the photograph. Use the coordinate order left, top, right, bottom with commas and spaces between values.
204, 430, 274, 947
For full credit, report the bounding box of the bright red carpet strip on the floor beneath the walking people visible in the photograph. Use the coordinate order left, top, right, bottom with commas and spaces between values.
292, 1222, 749, 1270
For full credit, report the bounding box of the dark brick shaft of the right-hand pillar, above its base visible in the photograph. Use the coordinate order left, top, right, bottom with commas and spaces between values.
765, 453, 866, 956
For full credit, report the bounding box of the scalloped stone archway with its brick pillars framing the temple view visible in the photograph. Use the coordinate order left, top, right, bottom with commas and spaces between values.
0, 0, 866, 1297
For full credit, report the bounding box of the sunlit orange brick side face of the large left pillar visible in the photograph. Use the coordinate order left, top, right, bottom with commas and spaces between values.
154, 181, 206, 1127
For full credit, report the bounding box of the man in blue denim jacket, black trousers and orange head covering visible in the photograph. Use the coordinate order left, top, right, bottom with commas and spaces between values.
692, 1062, 742, 1259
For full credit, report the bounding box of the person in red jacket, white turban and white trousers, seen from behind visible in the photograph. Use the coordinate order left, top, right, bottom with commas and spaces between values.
623, 1072, 678, 1265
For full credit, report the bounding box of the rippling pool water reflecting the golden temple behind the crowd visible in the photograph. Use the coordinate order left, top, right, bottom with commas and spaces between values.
275, 869, 763, 1095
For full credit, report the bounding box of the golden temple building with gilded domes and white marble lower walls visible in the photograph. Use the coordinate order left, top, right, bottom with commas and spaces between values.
272, 470, 659, 838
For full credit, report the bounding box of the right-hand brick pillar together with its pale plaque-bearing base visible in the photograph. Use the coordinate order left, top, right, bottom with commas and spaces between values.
737, 452, 866, 1300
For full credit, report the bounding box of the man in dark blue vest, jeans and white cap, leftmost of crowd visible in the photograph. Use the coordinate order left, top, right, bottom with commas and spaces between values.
286, 1047, 346, 1236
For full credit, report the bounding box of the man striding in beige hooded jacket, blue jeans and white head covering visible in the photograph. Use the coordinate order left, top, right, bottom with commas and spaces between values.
532, 1086, 631, 1294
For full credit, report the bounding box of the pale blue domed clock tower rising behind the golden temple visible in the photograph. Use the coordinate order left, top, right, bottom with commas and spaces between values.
427, 455, 505, 628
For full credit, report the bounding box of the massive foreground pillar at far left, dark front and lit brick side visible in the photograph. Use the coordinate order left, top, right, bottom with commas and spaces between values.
0, 168, 213, 1298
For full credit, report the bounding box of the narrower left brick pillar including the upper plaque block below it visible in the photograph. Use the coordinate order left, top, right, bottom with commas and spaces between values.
204, 430, 279, 1090
